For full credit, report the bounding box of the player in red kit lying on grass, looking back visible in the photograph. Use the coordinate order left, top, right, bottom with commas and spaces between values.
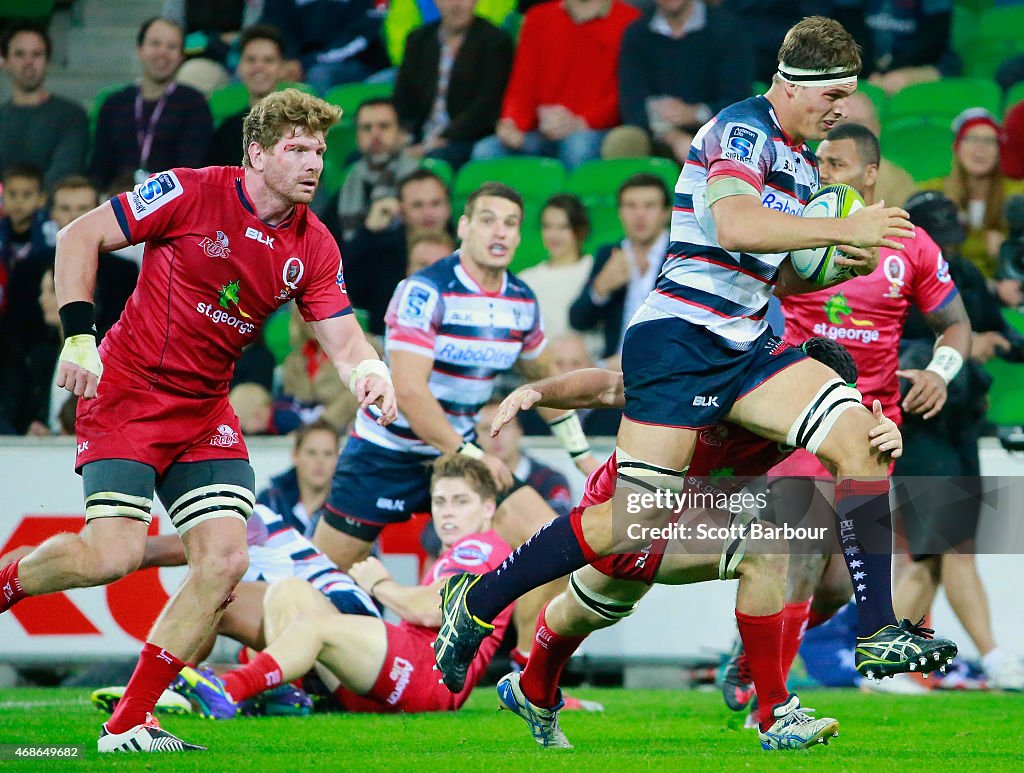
172, 455, 511, 719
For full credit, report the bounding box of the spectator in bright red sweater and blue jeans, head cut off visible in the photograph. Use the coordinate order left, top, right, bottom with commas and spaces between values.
473, 0, 640, 169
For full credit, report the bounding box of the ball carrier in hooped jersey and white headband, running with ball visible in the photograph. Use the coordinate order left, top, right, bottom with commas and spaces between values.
434, 16, 955, 713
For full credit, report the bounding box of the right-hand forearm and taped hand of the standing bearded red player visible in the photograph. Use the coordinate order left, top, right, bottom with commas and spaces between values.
309, 314, 398, 426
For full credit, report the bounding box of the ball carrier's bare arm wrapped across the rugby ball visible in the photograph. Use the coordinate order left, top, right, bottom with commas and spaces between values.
708, 186, 913, 254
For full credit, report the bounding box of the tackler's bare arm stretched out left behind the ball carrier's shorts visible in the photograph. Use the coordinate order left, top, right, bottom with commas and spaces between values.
490, 368, 626, 437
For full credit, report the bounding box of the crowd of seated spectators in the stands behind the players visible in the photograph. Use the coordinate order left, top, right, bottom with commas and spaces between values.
0, 0, 1024, 442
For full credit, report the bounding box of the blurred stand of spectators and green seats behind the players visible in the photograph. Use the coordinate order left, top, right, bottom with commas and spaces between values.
0, 0, 1024, 448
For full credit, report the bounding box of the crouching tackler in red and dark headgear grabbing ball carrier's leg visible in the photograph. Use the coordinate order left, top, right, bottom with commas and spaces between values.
492, 339, 902, 749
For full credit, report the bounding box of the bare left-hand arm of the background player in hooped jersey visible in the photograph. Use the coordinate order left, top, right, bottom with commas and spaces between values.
389, 349, 512, 489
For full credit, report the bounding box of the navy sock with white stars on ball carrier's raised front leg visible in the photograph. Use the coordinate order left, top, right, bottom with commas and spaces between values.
836, 478, 896, 637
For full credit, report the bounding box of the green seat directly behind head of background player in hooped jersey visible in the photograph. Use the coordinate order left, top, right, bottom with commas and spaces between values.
452, 156, 565, 215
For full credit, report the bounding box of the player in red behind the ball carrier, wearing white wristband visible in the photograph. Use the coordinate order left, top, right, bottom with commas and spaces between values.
722, 123, 971, 711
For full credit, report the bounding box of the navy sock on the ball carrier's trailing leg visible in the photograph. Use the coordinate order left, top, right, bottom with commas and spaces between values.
466, 516, 587, 621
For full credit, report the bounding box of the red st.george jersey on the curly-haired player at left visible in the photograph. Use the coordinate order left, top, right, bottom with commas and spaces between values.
100, 167, 352, 396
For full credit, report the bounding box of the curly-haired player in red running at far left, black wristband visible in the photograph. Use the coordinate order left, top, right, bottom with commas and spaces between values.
0, 89, 396, 751
